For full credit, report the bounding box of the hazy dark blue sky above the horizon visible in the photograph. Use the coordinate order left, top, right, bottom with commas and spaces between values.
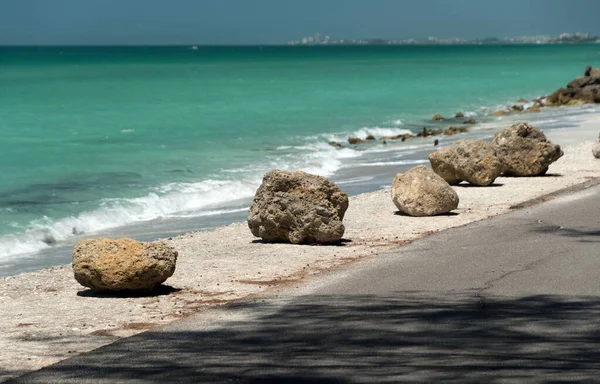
0, 0, 600, 45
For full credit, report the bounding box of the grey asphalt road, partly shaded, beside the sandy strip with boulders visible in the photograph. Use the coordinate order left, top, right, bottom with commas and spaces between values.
13, 186, 600, 384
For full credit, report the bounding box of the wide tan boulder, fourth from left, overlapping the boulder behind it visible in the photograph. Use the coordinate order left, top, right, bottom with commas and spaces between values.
429, 139, 502, 186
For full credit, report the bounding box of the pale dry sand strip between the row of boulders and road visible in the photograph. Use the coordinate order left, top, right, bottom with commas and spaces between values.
0, 114, 600, 381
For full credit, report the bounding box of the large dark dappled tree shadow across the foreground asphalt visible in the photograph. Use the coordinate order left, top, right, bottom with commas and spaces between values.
11, 293, 600, 384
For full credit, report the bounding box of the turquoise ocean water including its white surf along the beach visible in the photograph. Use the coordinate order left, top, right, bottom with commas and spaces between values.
0, 45, 600, 270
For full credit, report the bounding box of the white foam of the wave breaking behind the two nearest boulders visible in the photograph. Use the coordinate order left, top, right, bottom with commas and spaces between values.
0, 140, 362, 259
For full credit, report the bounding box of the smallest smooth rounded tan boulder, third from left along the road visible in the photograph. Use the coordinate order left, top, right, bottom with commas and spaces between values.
392, 165, 458, 216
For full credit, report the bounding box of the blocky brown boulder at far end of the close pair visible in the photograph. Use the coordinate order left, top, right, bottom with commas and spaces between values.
492, 123, 563, 176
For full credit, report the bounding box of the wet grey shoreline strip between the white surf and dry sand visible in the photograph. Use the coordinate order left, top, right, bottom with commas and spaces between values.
0, 105, 600, 278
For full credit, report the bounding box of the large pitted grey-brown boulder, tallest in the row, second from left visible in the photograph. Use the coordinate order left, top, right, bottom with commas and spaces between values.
248, 170, 348, 244
